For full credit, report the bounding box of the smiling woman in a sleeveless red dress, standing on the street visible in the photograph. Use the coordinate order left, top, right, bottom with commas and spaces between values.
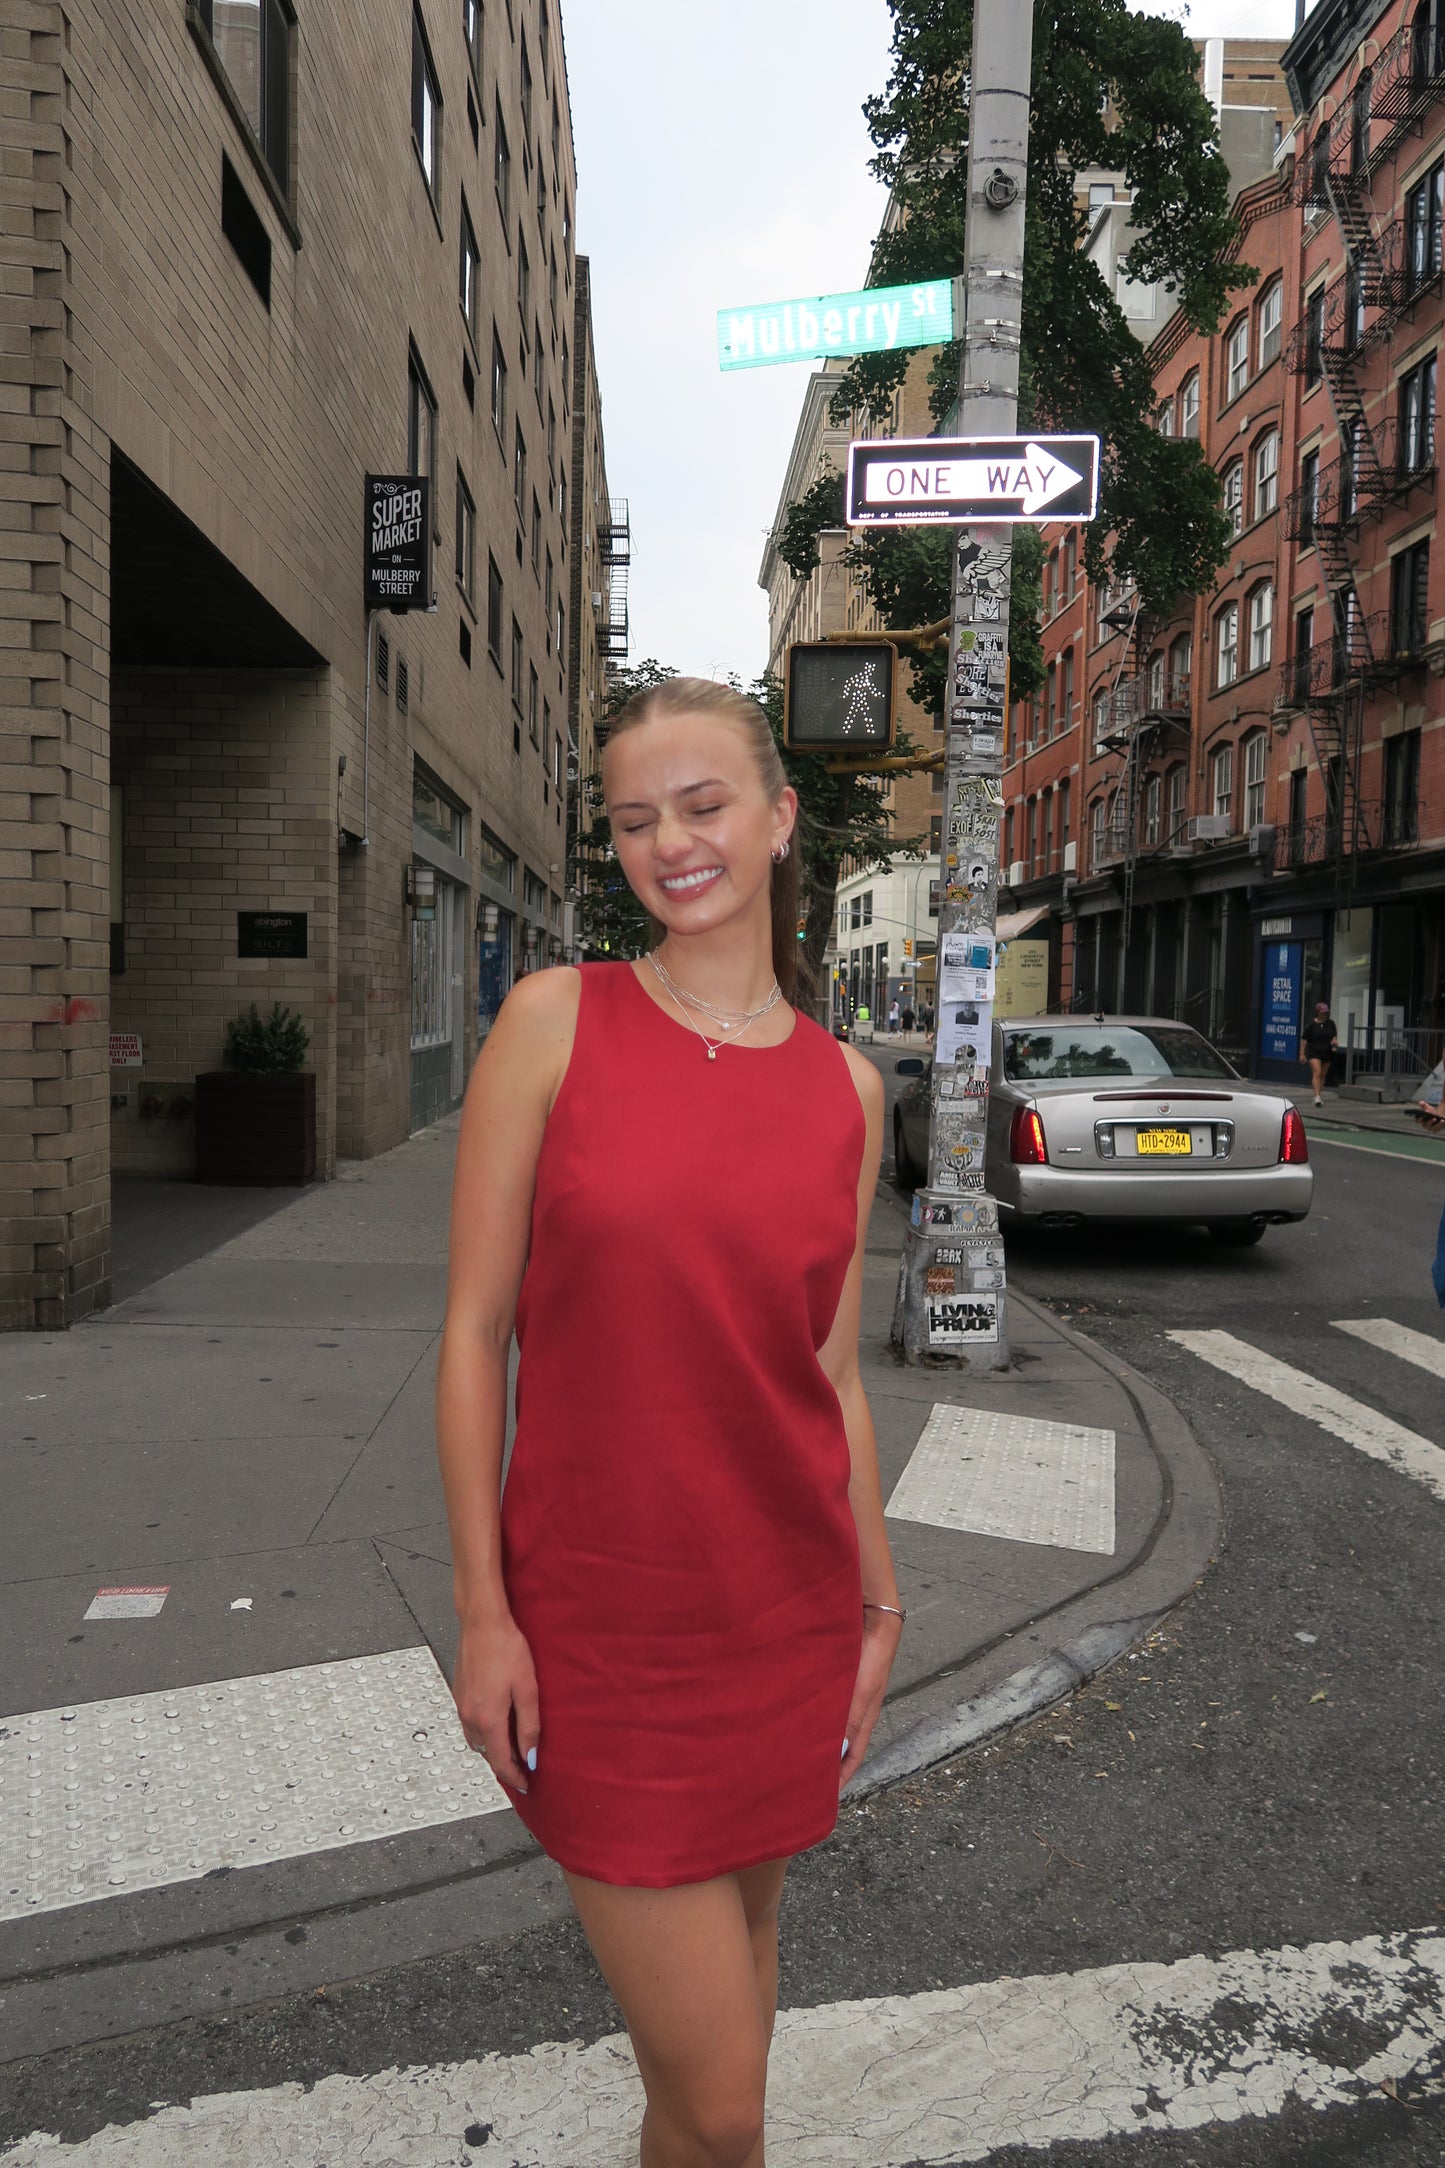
438, 679, 903, 2168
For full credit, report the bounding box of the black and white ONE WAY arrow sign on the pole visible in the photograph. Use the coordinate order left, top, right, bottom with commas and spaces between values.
847, 436, 1098, 527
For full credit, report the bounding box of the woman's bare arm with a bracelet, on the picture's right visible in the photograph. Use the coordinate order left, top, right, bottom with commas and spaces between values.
819, 1047, 903, 1786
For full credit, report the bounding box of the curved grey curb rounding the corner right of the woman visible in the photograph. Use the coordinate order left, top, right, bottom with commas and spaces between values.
841, 1290, 1224, 1804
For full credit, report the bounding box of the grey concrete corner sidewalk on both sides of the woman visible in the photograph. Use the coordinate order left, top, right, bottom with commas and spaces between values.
0, 1117, 1220, 2055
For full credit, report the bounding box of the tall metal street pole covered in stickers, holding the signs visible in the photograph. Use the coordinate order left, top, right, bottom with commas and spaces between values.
893, 0, 1033, 1370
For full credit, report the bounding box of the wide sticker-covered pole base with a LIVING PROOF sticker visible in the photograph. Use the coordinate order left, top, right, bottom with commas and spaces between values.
890, 1190, 1010, 1370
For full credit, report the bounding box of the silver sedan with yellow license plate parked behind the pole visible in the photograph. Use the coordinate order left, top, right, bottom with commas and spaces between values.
893, 1017, 1315, 1244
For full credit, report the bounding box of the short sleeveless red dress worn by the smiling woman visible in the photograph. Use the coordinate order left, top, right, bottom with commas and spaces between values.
500, 963, 864, 1888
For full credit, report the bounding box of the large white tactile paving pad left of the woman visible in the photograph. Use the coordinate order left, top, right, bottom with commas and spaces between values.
0, 1648, 509, 1919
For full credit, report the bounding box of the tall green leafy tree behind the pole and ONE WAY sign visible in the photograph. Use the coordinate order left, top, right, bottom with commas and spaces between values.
780, 0, 1257, 667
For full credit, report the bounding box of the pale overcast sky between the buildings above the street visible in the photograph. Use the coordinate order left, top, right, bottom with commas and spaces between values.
563, 0, 1296, 681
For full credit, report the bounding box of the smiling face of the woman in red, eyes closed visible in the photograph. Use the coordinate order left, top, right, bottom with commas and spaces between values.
602, 715, 797, 934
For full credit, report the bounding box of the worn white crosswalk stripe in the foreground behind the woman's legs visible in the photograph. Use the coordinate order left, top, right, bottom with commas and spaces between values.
0, 1930, 1445, 2168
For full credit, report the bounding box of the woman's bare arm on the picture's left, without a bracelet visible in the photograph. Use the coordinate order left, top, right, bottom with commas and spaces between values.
435, 969, 581, 1791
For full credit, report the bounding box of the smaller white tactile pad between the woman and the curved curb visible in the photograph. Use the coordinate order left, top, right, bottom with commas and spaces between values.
886, 1405, 1114, 1554
